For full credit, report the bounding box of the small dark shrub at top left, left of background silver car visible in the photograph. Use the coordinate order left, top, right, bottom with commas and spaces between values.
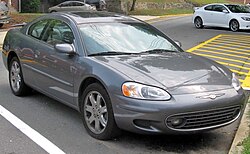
21, 0, 40, 13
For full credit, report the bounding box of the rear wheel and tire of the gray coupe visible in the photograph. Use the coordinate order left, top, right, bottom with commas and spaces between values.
9, 57, 31, 96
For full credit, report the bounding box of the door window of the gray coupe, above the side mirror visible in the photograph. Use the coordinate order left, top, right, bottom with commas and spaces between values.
43, 20, 74, 45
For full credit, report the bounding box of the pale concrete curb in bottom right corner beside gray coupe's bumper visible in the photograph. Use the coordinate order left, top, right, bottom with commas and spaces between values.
228, 103, 250, 154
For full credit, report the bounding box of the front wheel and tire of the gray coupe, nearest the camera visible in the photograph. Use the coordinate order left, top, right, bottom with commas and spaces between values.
81, 83, 120, 140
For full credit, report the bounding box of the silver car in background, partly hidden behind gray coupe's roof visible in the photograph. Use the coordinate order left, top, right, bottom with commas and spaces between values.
48, 1, 96, 13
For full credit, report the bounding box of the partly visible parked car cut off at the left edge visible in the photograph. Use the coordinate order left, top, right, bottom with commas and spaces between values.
0, 1, 10, 27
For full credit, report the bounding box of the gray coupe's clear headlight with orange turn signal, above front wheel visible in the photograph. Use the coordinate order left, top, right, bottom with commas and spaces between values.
122, 82, 171, 100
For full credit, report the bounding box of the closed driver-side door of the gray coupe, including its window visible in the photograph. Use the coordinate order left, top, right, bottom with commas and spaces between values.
33, 20, 76, 105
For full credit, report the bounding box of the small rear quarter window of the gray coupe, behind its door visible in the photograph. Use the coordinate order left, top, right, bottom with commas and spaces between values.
28, 20, 48, 39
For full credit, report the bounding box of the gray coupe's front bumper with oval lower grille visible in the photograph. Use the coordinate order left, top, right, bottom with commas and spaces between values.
112, 89, 247, 134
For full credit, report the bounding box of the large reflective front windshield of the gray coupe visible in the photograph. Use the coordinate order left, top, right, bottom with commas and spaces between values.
80, 23, 178, 55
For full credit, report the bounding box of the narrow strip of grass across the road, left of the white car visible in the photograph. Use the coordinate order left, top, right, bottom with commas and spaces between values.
129, 9, 193, 16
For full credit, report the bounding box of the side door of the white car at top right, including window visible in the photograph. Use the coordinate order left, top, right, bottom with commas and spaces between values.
212, 5, 229, 27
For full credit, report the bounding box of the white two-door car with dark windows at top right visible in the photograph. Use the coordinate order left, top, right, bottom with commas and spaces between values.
193, 4, 250, 31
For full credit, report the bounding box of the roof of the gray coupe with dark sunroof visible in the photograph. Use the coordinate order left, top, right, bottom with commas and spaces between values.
52, 11, 142, 25
